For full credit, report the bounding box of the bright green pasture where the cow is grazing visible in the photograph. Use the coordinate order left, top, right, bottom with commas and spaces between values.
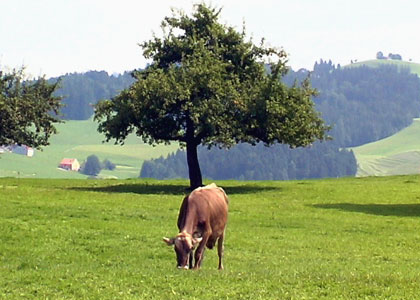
0, 176, 420, 299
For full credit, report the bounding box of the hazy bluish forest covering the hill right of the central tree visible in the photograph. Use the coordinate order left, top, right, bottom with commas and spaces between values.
306, 61, 420, 147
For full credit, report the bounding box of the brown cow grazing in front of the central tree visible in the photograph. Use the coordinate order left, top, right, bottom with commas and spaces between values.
163, 183, 228, 270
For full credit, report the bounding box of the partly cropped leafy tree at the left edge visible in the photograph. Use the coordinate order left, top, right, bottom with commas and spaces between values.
0, 69, 61, 148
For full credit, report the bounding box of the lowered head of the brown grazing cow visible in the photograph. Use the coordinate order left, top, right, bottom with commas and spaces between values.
163, 232, 202, 269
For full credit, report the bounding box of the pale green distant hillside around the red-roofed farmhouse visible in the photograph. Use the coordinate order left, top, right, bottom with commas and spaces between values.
0, 119, 178, 178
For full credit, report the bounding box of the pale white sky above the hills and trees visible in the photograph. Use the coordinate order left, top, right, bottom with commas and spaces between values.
0, 0, 420, 77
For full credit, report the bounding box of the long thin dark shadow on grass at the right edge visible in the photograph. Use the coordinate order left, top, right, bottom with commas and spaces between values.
313, 203, 420, 217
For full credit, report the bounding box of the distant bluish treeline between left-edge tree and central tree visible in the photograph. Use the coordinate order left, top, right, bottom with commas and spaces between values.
50, 71, 134, 120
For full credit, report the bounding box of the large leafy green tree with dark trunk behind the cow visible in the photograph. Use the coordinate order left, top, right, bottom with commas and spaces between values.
95, 4, 327, 188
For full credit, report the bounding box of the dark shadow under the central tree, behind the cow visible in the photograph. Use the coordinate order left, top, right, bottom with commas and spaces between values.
69, 184, 280, 196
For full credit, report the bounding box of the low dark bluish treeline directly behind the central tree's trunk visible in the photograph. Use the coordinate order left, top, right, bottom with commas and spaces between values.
140, 143, 357, 180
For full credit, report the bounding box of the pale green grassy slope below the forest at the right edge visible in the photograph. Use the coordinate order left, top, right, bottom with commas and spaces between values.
353, 119, 420, 176
